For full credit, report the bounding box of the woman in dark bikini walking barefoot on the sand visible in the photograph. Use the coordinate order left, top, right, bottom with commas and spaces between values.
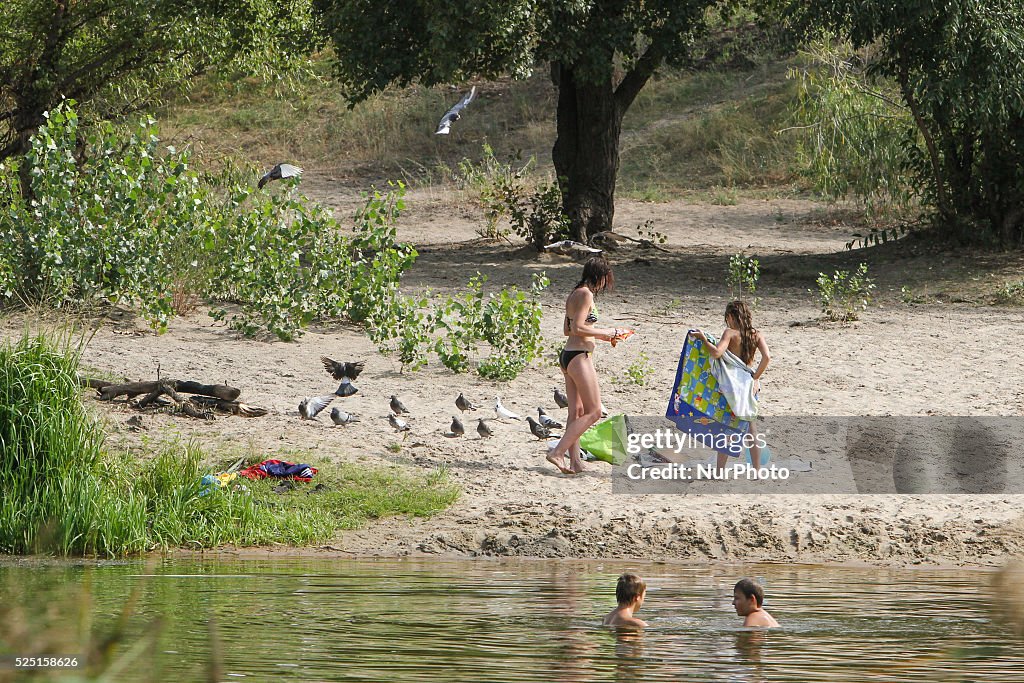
548, 256, 624, 474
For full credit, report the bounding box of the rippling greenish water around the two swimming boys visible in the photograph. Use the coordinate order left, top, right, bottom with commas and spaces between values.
0, 558, 1024, 683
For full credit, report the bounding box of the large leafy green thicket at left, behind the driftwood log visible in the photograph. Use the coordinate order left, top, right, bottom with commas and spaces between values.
0, 102, 416, 339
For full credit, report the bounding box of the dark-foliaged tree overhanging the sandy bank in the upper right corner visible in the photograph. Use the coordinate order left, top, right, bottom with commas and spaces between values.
791, 0, 1024, 245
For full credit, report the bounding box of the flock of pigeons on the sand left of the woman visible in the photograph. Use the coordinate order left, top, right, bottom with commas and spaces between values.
299, 355, 581, 439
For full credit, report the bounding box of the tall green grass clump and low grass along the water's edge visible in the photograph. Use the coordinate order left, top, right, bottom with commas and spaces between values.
0, 336, 459, 556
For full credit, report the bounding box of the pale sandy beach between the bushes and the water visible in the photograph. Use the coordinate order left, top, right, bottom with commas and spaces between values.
9, 185, 1024, 565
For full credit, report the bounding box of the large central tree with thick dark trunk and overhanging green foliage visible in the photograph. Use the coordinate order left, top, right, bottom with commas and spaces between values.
314, 0, 725, 240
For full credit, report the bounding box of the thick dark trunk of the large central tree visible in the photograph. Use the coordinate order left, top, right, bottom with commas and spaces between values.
551, 63, 623, 242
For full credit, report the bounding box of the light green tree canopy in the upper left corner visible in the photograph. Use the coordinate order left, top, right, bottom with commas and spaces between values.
0, 0, 314, 160
